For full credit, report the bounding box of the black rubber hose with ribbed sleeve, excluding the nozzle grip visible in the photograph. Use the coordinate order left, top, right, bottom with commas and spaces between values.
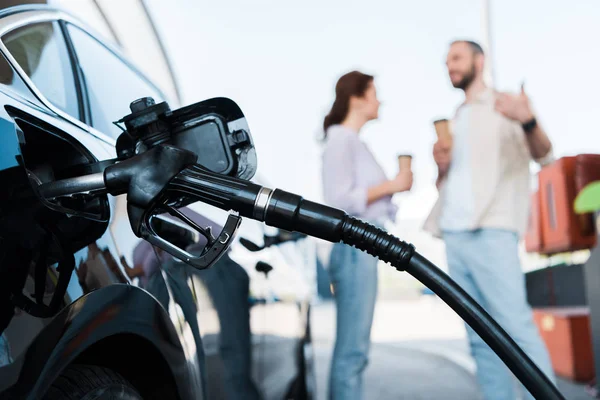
342, 217, 564, 400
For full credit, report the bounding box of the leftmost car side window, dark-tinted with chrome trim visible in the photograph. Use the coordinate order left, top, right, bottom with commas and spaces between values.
2, 22, 79, 118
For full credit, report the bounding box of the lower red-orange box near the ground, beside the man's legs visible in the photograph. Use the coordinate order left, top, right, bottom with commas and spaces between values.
533, 307, 595, 382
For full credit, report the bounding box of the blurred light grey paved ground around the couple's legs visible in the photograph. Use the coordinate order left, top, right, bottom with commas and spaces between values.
312, 296, 591, 400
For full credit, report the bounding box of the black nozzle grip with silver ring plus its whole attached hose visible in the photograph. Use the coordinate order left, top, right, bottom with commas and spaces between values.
169, 167, 564, 400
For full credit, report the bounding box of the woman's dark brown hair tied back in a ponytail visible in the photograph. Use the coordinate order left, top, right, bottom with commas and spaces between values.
323, 71, 374, 136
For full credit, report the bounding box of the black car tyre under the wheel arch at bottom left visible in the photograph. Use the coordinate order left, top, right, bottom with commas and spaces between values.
44, 365, 143, 400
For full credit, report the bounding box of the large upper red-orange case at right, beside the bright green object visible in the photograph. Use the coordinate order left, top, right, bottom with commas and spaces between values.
539, 155, 600, 254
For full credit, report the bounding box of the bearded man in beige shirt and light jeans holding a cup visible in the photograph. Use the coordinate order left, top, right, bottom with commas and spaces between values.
425, 41, 554, 400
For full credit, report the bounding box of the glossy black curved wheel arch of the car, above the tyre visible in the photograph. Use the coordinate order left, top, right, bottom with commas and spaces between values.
4, 284, 202, 400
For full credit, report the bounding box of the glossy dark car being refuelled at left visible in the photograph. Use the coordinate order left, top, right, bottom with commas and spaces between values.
0, 5, 316, 400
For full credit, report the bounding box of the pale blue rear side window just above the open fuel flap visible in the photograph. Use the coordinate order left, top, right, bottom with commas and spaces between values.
68, 24, 164, 138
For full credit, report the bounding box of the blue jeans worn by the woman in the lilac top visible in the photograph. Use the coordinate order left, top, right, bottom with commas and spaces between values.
329, 243, 377, 400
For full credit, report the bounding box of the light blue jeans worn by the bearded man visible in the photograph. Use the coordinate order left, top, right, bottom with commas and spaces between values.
444, 229, 555, 400
